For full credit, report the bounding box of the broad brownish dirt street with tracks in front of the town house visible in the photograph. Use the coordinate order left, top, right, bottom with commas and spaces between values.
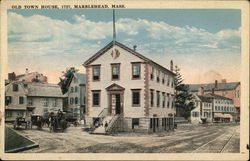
10, 124, 240, 153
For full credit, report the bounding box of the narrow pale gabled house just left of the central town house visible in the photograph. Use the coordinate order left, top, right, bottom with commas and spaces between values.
64, 73, 86, 119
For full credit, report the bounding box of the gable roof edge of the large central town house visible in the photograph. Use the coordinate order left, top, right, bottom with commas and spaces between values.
83, 41, 176, 76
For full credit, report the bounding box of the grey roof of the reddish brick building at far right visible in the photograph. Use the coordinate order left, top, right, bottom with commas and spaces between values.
189, 82, 240, 92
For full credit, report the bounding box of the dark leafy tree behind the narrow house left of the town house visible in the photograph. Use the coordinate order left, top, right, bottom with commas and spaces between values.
59, 67, 78, 94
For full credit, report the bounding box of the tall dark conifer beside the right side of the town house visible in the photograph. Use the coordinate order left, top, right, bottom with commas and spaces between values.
174, 65, 195, 119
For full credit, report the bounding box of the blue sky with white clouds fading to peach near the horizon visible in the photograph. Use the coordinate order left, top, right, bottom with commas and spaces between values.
8, 9, 241, 83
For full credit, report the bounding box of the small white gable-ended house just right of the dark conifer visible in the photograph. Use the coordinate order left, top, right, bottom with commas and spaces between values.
190, 94, 213, 124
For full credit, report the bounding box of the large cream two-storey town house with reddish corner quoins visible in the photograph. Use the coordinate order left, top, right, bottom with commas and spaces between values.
84, 41, 175, 133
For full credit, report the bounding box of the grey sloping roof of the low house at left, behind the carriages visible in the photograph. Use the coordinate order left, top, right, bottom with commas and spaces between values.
26, 82, 63, 97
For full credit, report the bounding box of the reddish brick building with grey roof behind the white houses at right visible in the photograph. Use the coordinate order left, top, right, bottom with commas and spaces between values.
189, 79, 241, 118
